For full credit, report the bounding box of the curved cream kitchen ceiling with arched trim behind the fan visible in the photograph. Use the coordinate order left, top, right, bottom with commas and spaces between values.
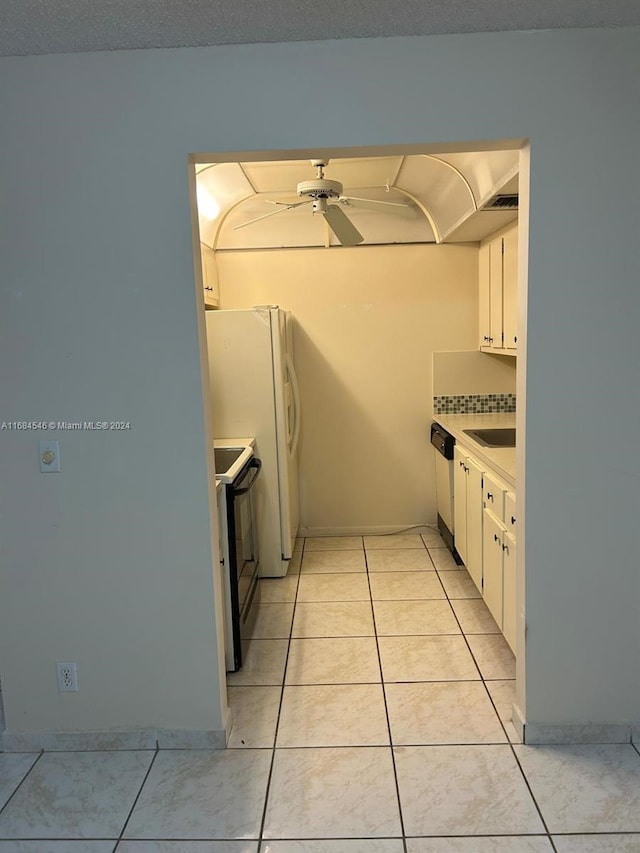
195, 150, 519, 252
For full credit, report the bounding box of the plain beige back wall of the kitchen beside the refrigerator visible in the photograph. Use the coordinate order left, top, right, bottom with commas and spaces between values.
218, 245, 478, 534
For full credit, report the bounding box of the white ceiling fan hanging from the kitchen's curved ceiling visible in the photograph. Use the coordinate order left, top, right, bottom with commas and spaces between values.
234, 160, 409, 246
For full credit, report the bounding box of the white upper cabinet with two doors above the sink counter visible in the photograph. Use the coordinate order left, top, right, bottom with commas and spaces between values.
478, 226, 518, 355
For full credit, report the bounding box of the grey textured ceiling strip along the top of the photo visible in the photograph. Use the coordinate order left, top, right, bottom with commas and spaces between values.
0, 0, 640, 56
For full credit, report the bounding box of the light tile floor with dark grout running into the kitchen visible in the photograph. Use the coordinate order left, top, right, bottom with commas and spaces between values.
0, 533, 640, 853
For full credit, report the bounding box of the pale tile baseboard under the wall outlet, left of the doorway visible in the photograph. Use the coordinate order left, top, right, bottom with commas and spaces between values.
2, 718, 231, 752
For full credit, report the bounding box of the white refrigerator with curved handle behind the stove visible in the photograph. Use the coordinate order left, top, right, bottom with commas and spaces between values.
206, 305, 300, 577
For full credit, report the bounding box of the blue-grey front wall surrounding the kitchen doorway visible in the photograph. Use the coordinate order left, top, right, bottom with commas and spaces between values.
0, 23, 640, 732
